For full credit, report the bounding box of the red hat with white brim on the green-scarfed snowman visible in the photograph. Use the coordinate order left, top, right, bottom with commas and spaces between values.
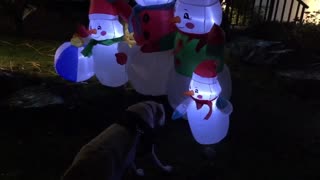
89, 0, 118, 20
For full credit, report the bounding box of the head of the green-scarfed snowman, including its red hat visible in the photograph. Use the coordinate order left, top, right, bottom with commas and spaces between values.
89, 0, 123, 40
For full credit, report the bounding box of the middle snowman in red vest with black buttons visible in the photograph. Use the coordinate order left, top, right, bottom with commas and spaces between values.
127, 0, 176, 96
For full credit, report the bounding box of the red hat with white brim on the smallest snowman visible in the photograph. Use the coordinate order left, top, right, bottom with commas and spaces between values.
192, 60, 217, 84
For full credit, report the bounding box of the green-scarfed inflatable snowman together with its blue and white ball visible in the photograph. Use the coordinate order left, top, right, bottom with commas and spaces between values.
55, 0, 131, 87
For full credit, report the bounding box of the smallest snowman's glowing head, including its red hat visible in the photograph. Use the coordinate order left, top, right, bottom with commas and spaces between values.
189, 60, 221, 101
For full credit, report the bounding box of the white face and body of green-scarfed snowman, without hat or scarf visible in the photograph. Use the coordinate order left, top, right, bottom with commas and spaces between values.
89, 4, 128, 87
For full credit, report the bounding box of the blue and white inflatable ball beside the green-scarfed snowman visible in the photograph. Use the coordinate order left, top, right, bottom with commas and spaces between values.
54, 42, 94, 82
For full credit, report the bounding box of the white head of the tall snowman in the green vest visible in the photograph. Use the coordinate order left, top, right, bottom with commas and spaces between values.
174, 0, 222, 34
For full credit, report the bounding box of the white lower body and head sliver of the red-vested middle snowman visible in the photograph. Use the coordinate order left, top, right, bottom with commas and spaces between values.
127, 0, 174, 96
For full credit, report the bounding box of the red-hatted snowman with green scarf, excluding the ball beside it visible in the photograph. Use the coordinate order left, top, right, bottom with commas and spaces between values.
82, 0, 128, 87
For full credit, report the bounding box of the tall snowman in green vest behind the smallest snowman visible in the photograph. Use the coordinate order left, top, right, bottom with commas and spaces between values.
168, 0, 231, 109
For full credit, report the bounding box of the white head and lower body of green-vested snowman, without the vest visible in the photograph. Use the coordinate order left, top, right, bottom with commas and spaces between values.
168, 0, 232, 109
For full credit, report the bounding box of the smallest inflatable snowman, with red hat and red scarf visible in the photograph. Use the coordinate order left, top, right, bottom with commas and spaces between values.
172, 60, 233, 145
